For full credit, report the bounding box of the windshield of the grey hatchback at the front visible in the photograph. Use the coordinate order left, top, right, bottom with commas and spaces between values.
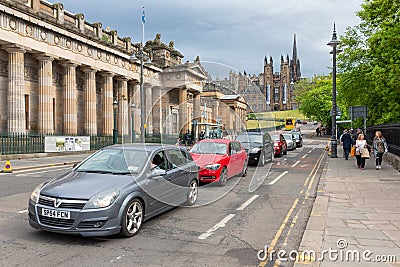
75, 149, 149, 174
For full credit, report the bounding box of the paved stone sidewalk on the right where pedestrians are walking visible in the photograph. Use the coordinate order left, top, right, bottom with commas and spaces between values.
294, 147, 400, 267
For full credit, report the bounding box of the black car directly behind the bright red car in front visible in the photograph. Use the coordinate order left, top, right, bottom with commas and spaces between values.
236, 131, 274, 166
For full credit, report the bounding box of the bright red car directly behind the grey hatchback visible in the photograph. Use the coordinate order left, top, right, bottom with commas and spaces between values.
190, 139, 247, 186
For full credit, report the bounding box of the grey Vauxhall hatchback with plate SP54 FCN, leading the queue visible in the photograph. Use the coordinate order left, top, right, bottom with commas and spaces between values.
28, 144, 199, 237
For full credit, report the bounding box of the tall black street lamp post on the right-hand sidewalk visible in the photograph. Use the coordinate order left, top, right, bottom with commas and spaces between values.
327, 24, 340, 158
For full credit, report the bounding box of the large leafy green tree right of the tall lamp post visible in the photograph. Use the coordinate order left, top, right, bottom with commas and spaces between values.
338, 0, 400, 125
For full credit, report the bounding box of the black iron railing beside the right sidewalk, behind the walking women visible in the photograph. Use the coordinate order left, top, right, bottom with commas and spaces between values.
367, 123, 400, 156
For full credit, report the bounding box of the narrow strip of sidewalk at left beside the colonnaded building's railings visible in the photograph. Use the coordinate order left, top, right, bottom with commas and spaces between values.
1, 152, 94, 171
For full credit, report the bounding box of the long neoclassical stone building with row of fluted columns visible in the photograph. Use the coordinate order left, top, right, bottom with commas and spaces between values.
0, 0, 245, 143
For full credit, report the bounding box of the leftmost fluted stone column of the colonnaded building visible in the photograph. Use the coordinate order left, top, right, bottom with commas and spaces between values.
6, 46, 25, 133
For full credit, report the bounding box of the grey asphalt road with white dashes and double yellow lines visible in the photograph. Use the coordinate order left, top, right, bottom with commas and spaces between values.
0, 126, 326, 266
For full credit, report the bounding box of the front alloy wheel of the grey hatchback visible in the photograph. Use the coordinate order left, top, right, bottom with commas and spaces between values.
119, 198, 144, 237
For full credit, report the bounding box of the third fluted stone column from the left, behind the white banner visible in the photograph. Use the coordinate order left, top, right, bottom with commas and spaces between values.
61, 63, 78, 135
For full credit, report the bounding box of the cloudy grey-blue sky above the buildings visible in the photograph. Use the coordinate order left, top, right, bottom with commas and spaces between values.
61, 0, 363, 77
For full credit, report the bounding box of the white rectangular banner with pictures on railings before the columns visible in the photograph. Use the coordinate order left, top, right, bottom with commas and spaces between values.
44, 136, 90, 152
